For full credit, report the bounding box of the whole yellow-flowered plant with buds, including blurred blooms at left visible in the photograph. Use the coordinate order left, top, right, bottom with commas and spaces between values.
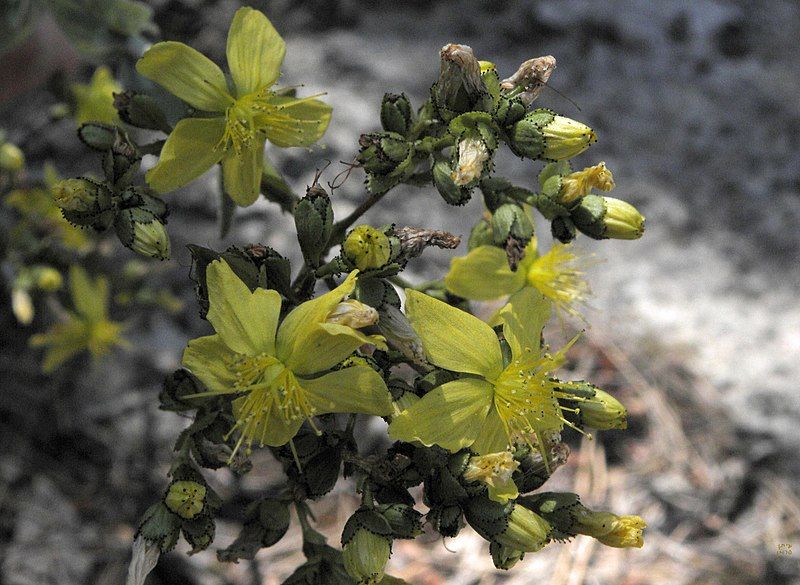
0, 8, 645, 584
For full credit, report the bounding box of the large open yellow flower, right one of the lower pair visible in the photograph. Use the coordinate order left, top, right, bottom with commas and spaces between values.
389, 287, 577, 455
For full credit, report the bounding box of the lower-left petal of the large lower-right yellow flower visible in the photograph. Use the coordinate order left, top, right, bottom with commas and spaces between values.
389, 378, 493, 453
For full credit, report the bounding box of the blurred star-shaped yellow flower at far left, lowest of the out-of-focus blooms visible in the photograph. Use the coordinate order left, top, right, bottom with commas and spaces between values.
30, 265, 127, 373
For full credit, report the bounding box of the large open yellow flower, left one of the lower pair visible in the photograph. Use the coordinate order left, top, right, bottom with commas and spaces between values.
183, 260, 393, 450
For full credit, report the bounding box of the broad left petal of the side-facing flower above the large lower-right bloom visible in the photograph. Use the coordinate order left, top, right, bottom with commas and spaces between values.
444, 246, 525, 301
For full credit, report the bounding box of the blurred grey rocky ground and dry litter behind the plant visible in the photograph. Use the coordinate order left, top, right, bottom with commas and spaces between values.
0, 0, 800, 585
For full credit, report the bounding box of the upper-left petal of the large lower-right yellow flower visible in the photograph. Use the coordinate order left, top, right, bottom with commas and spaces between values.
406, 289, 503, 378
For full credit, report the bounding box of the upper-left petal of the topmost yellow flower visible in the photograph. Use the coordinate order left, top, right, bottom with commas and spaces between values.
136, 41, 233, 112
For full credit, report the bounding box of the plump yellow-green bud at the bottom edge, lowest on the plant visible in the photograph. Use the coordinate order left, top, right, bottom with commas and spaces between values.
342, 509, 392, 585
